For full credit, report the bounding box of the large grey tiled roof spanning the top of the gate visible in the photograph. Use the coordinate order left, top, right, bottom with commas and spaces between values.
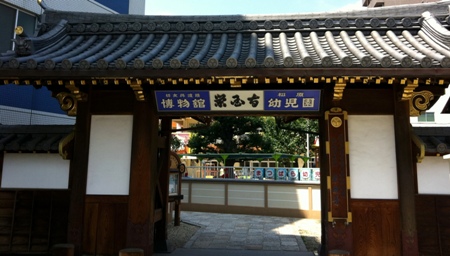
0, 4, 450, 74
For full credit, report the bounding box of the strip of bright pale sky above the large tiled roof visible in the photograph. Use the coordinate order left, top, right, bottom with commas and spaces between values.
145, 0, 362, 15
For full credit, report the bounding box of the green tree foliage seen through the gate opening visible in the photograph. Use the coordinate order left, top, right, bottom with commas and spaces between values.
188, 117, 318, 154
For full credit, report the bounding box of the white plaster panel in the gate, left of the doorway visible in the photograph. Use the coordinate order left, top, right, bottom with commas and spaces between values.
86, 115, 133, 195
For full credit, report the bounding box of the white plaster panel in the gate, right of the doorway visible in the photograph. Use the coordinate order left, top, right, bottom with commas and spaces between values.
348, 115, 398, 199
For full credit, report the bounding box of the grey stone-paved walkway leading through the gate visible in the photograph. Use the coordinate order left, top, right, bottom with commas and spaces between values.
157, 212, 314, 256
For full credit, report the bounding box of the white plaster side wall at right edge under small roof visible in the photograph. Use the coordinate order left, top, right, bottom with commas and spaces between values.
417, 156, 450, 195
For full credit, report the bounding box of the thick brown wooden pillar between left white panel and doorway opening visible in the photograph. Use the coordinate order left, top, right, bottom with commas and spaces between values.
126, 101, 158, 255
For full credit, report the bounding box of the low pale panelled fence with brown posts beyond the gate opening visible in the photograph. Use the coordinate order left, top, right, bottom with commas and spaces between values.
181, 178, 321, 219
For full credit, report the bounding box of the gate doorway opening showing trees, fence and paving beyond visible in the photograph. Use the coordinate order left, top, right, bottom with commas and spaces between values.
163, 115, 322, 252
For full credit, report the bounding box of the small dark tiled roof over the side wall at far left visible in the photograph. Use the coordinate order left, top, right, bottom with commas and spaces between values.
0, 125, 73, 153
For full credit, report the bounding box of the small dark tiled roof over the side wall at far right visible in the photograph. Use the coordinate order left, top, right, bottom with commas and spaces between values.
413, 127, 450, 155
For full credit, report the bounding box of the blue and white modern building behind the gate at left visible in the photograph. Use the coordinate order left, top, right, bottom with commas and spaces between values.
0, 0, 145, 125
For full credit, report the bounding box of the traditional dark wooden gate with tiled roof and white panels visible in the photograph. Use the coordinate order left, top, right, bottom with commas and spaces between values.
0, 1, 450, 256
